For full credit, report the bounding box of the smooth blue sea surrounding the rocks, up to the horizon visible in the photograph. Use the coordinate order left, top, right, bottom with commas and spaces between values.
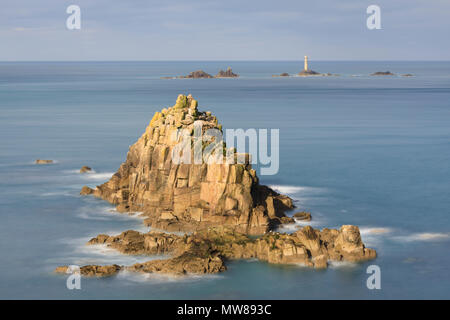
0, 61, 450, 299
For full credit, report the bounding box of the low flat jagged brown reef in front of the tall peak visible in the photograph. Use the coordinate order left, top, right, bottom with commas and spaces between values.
56, 225, 376, 276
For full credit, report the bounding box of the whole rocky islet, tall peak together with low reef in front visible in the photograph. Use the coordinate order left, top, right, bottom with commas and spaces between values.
55, 95, 376, 276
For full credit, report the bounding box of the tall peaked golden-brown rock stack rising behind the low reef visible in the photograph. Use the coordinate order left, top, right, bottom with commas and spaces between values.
81, 95, 293, 234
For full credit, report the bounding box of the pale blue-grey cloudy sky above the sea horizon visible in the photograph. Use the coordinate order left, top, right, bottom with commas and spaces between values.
0, 0, 450, 61
